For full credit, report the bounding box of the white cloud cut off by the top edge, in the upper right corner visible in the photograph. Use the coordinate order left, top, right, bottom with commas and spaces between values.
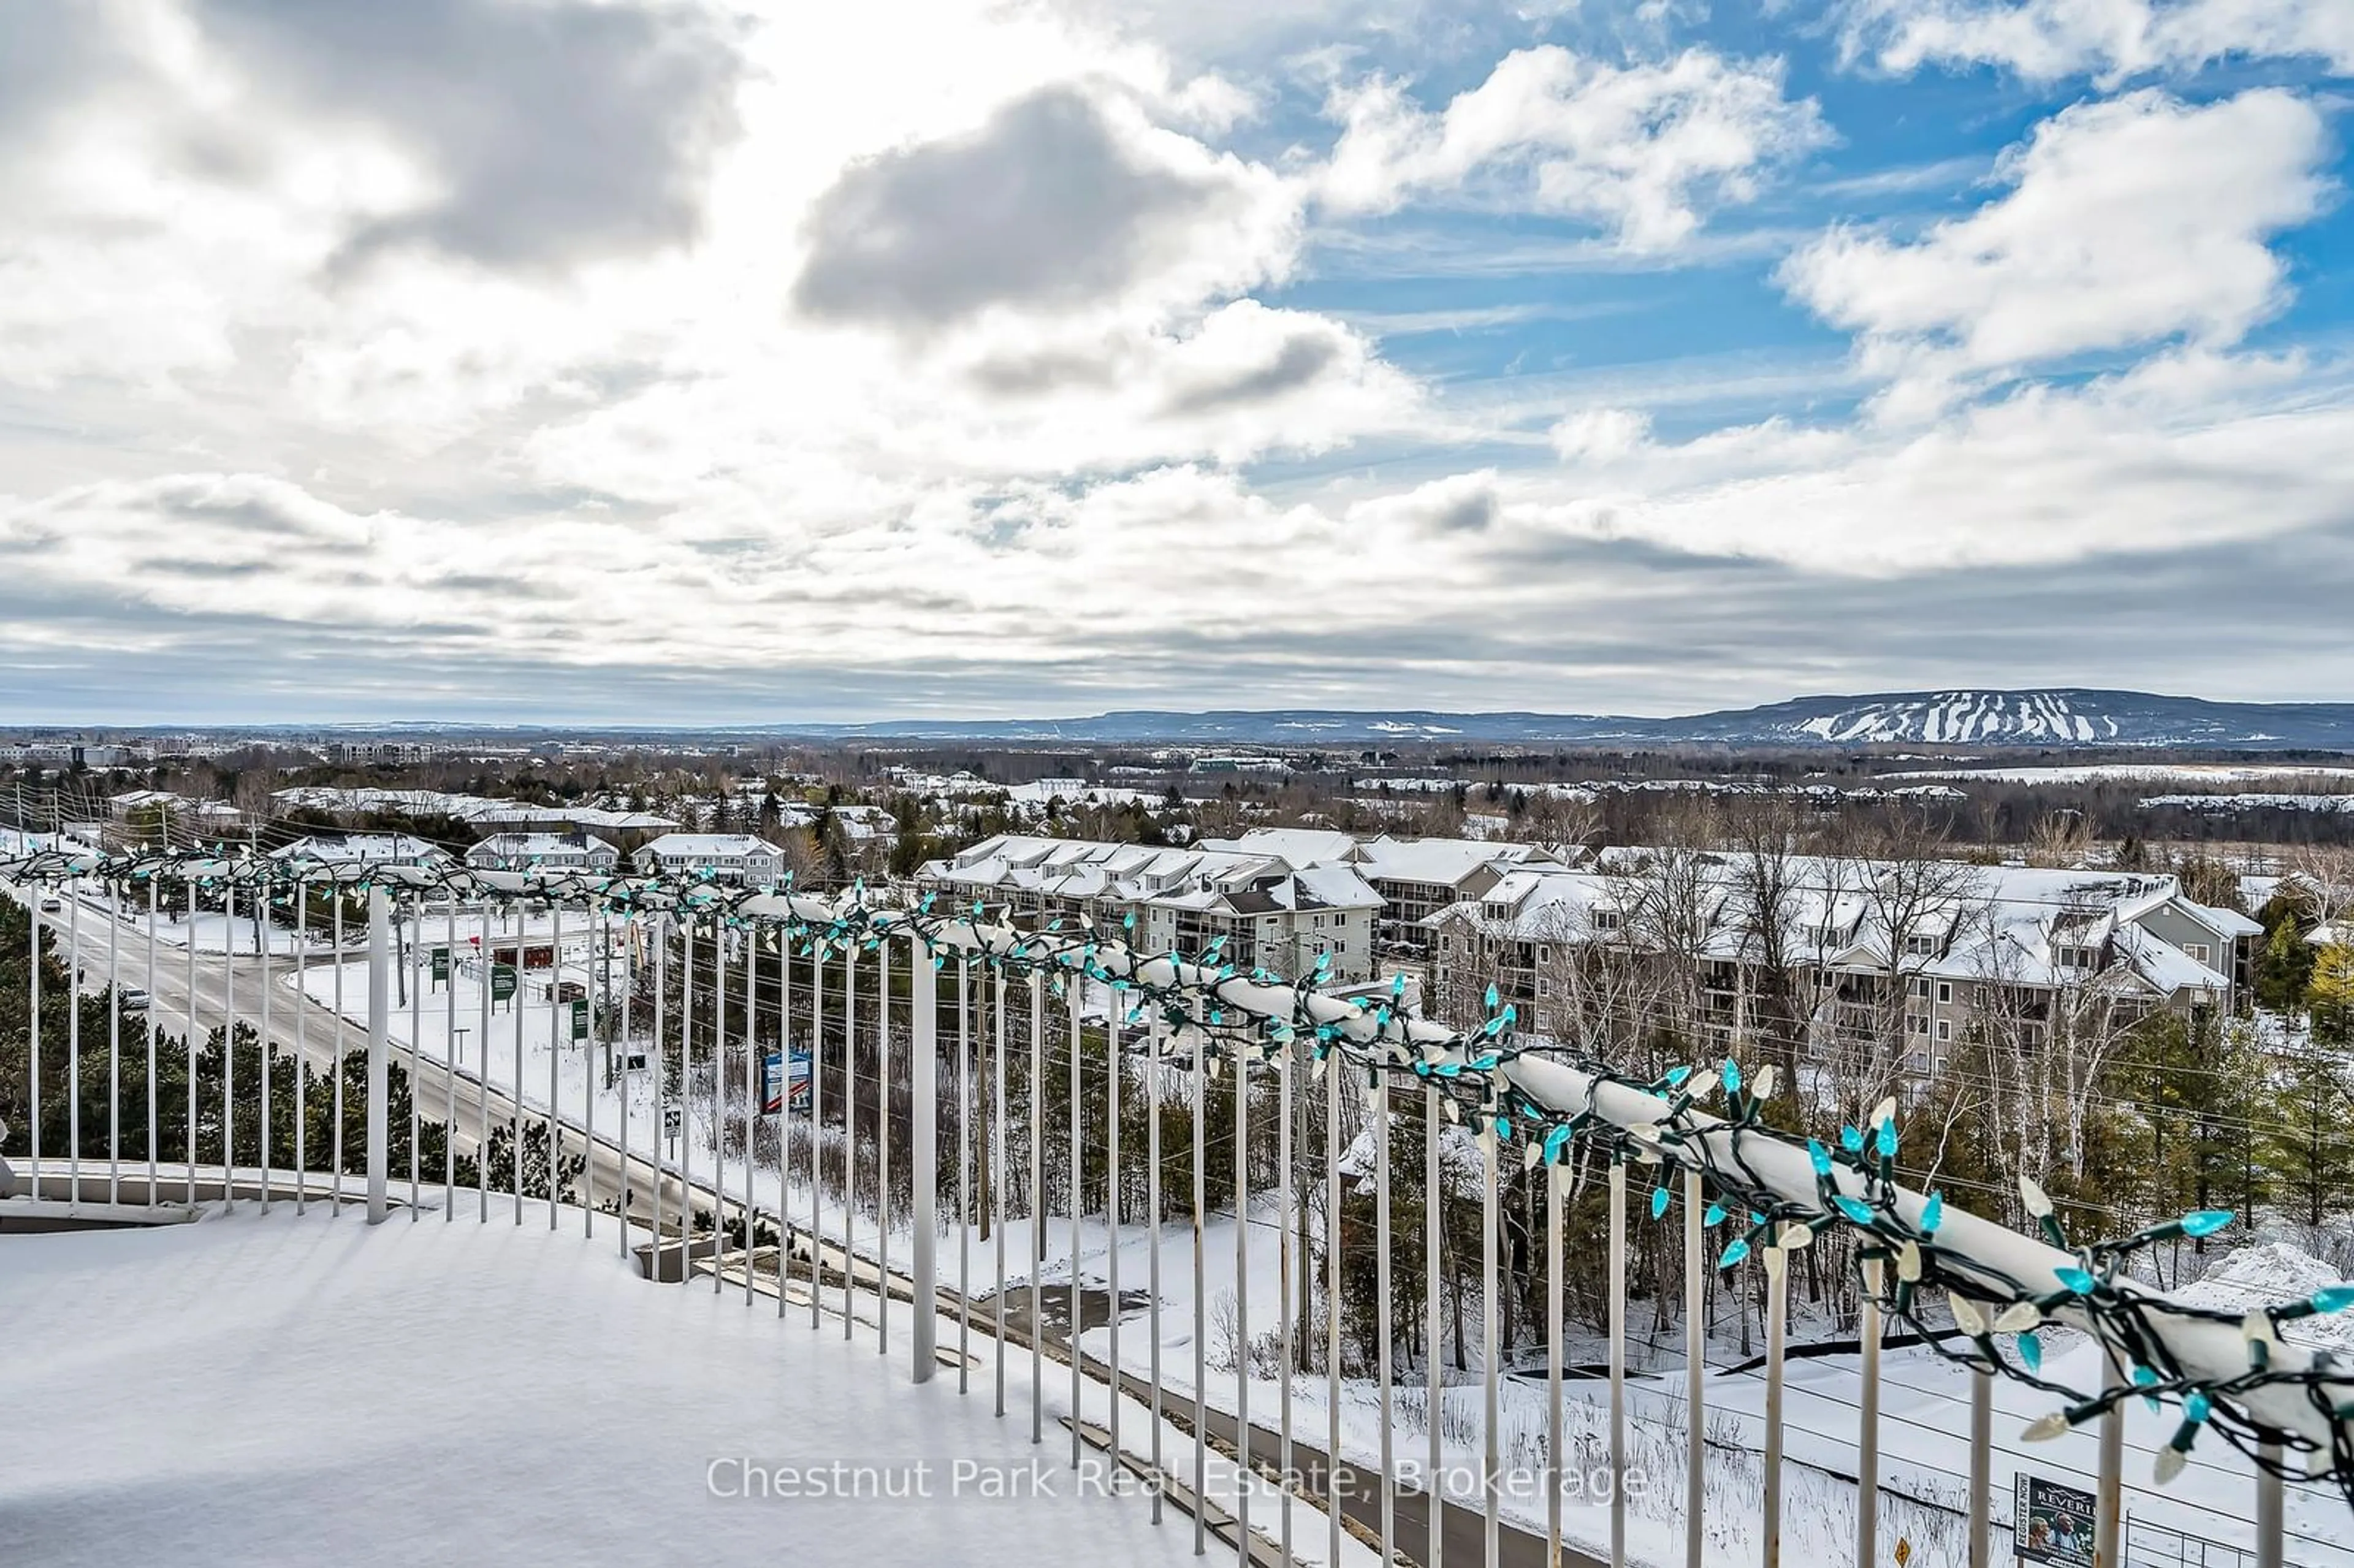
1841, 0, 2354, 82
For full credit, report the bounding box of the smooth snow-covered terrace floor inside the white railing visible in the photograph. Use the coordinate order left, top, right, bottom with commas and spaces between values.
0, 1206, 1252, 1568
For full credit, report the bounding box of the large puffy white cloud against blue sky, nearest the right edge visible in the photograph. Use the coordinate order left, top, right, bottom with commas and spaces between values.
1780, 89, 2328, 400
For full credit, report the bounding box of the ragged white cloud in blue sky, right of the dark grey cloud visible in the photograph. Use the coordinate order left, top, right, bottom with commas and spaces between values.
1318, 45, 1829, 252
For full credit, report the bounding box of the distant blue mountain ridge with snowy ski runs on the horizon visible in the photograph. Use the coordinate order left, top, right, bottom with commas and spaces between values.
774, 688, 2354, 751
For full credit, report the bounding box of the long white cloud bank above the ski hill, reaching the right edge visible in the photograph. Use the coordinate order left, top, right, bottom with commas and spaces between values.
1384, 353, 2354, 577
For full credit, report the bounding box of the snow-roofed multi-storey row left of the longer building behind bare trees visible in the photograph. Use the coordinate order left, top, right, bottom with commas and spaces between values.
916, 834, 1382, 982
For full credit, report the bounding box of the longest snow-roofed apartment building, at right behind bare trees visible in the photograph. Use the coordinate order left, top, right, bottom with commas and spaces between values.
1429, 850, 2262, 1073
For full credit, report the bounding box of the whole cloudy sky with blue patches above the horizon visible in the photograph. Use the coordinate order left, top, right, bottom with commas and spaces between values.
0, 0, 2354, 723
